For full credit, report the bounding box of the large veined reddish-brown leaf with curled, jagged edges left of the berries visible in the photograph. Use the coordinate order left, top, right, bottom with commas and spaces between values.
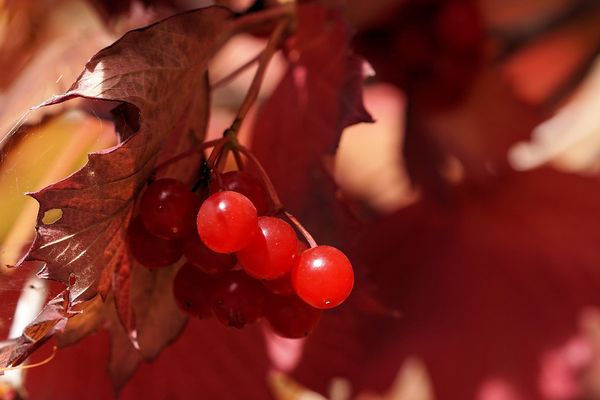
0, 3, 252, 388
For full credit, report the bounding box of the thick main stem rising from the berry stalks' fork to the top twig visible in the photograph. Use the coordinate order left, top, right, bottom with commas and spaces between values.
230, 19, 290, 133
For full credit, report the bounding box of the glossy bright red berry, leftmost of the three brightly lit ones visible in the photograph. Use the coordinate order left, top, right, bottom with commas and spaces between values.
196, 191, 258, 253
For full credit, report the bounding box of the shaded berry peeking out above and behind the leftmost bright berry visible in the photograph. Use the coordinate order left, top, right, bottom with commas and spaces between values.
211, 171, 270, 215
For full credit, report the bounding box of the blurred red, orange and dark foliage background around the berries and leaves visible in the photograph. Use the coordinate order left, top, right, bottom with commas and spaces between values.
0, 0, 600, 400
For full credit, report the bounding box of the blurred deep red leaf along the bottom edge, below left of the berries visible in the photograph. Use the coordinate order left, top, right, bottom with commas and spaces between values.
26, 320, 270, 399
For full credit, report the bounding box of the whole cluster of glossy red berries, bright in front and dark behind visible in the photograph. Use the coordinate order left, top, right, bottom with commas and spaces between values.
128, 171, 354, 338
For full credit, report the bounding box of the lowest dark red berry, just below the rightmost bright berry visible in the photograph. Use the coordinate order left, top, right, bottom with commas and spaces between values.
265, 296, 321, 339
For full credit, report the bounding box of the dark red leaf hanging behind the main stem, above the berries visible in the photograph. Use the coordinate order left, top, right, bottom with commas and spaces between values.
252, 5, 372, 225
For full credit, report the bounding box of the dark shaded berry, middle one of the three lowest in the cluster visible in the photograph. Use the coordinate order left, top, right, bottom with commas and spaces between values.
211, 271, 265, 329
